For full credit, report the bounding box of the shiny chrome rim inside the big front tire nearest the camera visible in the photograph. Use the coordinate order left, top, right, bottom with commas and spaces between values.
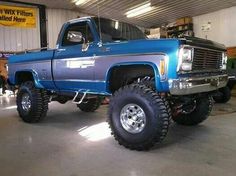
120, 104, 146, 134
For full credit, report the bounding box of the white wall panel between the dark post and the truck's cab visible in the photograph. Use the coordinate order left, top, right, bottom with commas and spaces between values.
47, 9, 86, 48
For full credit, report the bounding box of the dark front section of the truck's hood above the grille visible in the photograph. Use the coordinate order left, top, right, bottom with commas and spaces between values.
180, 37, 226, 51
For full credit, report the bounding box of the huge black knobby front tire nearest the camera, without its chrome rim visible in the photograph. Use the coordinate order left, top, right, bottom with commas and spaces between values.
108, 83, 170, 150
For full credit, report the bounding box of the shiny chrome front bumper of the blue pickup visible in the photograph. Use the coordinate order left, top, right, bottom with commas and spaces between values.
169, 74, 228, 95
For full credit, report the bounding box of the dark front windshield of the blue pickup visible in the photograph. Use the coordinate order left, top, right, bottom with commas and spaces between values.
94, 18, 146, 42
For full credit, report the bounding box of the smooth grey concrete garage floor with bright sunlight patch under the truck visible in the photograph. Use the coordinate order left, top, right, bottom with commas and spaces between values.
0, 97, 236, 176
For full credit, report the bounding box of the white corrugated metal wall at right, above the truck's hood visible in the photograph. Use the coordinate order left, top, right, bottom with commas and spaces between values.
193, 6, 236, 47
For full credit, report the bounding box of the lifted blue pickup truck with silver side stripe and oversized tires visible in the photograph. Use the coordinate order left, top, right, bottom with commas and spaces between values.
8, 17, 228, 150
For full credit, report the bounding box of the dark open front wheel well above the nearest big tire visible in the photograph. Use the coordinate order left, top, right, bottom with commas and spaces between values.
109, 65, 155, 93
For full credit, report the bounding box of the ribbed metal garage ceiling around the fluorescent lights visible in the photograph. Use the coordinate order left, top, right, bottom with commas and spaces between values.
13, 0, 236, 27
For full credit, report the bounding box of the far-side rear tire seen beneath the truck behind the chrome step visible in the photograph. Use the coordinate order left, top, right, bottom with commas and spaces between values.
77, 97, 102, 112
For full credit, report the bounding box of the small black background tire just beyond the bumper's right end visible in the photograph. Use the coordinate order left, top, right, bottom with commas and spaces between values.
213, 86, 231, 103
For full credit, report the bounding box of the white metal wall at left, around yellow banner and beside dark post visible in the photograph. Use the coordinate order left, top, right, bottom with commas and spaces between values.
0, 3, 85, 52
